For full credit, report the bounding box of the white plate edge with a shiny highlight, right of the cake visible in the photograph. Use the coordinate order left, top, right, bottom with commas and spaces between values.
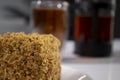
61, 66, 92, 80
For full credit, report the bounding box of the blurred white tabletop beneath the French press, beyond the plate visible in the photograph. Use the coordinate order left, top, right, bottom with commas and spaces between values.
61, 40, 120, 80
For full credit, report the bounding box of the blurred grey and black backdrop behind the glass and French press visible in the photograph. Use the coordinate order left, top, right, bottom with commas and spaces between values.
0, 0, 120, 40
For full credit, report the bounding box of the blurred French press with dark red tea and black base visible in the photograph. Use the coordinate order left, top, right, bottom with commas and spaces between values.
75, 0, 115, 57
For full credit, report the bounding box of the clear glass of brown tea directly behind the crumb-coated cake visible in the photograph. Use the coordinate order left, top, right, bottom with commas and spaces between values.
32, 0, 68, 46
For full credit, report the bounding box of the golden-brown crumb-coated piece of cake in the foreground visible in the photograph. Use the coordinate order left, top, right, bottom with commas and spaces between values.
0, 32, 61, 80
